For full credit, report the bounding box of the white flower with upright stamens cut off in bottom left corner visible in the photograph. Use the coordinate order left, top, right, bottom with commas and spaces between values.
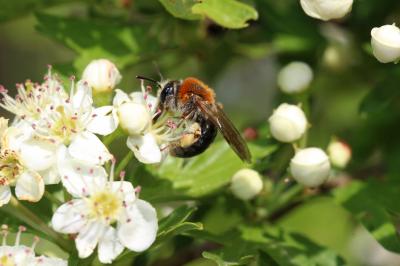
0, 225, 68, 266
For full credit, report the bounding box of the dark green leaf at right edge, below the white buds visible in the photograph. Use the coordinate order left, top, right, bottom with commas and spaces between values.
334, 179, 400, 252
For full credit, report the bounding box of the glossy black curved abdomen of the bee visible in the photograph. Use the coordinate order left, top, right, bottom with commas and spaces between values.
170, 117, 218, 158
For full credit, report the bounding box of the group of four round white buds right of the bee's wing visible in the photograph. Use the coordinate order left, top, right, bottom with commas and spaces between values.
268, 57, 351, 187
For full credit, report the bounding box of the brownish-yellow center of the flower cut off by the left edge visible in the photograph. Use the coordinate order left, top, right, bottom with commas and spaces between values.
0, 150, 22, 186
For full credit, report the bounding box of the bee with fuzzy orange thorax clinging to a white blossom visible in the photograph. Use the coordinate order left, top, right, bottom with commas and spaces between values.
137, 76, 251, 162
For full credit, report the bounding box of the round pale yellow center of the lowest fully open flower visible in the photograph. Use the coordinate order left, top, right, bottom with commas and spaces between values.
89, 191, 122, 224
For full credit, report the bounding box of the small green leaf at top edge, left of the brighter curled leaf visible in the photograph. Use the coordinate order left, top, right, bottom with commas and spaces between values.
160, 0, 201, 20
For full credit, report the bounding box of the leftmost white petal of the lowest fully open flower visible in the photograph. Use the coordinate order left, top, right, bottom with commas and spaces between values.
51, 199, 87, 234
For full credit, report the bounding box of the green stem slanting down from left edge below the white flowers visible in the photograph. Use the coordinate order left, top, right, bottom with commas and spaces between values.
2, 196, 71, 252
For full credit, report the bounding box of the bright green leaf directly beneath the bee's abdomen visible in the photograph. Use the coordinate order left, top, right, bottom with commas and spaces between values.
149, 141, 276, 197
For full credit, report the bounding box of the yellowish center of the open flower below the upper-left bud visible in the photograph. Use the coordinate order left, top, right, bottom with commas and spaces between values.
51, 106, 78, 145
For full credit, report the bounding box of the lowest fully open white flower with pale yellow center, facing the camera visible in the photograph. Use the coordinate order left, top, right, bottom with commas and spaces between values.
52, 160, 158, 263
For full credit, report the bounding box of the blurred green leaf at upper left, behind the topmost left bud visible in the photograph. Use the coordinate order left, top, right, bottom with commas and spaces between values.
36, 14, 158, 73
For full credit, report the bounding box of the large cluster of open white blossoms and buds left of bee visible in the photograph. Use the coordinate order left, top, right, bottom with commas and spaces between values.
0, 59, 194, 265
